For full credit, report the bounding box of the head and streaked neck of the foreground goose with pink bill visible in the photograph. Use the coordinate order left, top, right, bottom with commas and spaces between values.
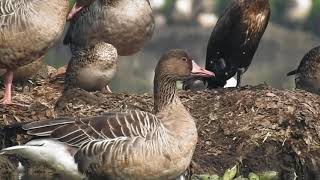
153, 49, 214, 113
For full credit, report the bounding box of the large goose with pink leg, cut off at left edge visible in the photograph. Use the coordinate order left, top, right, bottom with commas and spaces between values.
0, 0, 69, 104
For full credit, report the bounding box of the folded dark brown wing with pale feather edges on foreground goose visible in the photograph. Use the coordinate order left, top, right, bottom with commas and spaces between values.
23, 110, 161, 147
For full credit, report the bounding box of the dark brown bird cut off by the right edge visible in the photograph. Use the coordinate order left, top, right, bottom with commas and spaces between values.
288, 46, 320, 95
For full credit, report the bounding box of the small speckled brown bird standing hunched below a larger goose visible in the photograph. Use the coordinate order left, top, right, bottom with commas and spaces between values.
64, 42, 118, 91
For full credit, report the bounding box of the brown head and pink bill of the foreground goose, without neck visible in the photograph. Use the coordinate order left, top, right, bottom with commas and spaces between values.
155, 49, 214, 81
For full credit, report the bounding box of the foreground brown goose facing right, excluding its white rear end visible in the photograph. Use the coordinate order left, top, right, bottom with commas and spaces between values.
1, 49, 214, 180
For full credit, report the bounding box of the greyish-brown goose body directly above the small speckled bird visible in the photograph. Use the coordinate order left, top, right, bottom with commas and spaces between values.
64, 0, 154, 56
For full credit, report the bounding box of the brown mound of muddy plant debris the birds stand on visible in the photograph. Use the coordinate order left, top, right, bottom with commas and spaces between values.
0, 80, 320, 179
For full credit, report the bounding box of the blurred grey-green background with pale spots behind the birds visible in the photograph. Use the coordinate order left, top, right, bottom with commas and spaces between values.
46, 0, 320, 93
